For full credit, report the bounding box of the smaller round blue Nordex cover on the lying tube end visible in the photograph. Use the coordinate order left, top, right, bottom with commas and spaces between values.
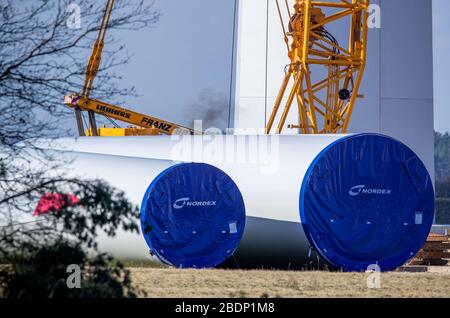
141, 163, 245, 268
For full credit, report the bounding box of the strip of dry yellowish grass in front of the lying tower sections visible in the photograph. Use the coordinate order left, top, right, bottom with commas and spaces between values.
130, 267, 450, 298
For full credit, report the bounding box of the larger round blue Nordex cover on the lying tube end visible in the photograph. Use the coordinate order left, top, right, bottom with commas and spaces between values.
300, 134, 434, 271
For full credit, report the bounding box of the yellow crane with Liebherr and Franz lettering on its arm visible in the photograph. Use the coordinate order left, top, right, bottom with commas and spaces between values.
64, 0, 200, 136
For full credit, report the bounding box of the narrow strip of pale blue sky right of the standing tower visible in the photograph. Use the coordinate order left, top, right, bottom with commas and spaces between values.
433, 0, 450, 132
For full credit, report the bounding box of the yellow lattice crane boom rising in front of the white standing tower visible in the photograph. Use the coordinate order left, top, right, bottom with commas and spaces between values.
266, 0, 369, 134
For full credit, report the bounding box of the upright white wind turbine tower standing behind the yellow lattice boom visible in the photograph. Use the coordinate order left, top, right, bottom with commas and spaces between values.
230, 0, 434, 177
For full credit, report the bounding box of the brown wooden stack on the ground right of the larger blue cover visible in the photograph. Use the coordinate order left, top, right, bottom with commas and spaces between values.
409, 233, 450, 266
